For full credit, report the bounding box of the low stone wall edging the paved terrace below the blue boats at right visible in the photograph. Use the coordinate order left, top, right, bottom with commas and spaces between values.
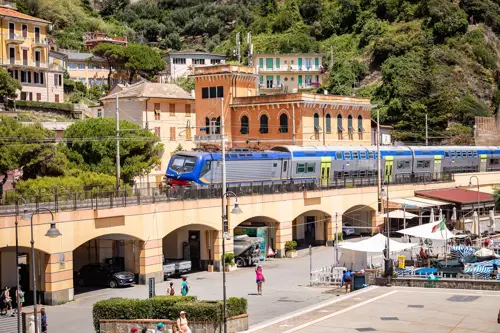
376, 277, 500, 291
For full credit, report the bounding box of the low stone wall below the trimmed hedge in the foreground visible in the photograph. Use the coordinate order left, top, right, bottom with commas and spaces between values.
100, 315, 248, 333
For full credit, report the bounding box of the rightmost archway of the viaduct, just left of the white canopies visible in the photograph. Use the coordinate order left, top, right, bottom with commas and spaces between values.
339, 205, 376, 237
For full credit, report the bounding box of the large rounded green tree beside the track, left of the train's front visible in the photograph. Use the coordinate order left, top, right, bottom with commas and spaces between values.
64, 118, 163, 183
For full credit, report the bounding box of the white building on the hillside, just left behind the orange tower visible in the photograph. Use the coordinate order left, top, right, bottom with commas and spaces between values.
159, 51, 226, 83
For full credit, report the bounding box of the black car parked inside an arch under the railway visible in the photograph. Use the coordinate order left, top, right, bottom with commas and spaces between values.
78, 264, 134, 288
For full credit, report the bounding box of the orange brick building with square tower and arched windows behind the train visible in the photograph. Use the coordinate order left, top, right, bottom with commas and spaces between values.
193, 65, 375, 149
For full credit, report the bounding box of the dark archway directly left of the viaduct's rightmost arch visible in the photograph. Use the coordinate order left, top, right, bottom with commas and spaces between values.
292, 210, 332, 248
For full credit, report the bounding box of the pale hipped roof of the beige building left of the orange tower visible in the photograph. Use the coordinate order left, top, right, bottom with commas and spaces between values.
101, 81, 194, 100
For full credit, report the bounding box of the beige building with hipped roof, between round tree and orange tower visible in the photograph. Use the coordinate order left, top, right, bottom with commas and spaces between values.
100, 81, 196, 184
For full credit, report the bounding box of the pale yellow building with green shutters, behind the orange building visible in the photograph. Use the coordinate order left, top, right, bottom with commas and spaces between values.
254, 53, 324, 95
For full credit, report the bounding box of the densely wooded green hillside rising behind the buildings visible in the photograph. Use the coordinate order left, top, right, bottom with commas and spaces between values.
18, 0, 500, 144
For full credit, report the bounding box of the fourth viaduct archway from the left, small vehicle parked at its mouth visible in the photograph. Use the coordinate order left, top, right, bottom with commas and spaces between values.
233, 216, 285, 260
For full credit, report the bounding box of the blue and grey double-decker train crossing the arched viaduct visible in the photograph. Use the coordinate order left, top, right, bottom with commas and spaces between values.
166, 146, 500, 187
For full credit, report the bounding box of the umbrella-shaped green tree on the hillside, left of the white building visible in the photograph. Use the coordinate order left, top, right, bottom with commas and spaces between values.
124, 44, 166, 83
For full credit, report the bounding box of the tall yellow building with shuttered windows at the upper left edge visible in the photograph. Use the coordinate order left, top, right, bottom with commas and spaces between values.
0, 7, 64, 102
